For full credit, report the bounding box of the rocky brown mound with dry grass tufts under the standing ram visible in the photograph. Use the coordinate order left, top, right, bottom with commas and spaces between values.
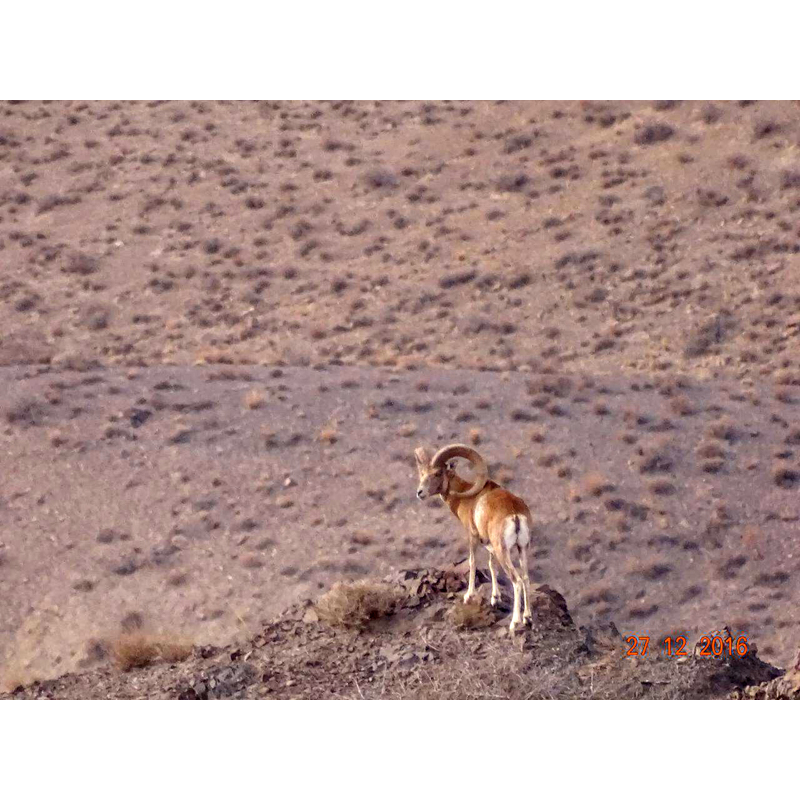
3, 565, 784, 699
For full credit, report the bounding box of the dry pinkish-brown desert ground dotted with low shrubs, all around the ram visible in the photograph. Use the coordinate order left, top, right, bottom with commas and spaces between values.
0, 101, 800, 697
